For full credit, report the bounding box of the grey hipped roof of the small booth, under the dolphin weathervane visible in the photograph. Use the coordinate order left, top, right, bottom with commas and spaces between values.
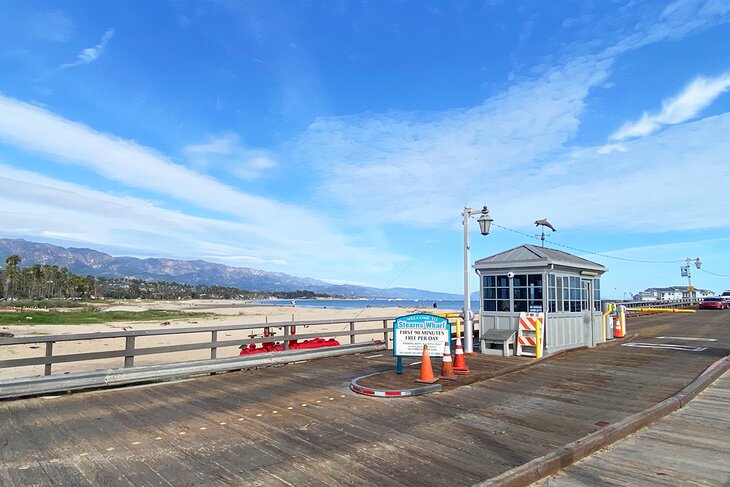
474, 245, 606, 274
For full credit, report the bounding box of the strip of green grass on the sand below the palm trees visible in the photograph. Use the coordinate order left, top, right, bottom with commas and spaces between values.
0, 308, 213, 325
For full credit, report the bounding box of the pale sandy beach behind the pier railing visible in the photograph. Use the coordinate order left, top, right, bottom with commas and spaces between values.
0, 300, 456, 379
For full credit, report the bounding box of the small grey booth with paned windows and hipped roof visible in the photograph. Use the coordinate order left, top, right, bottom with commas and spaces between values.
474, 245, 606, 354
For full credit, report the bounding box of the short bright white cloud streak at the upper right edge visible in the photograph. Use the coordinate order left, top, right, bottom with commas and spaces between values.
611, 73, 730, 141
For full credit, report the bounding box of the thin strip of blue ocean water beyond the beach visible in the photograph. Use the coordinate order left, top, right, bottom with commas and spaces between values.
252, 299, 479, 311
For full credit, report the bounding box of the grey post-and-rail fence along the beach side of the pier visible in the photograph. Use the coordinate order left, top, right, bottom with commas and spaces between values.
0, 317, 394, 376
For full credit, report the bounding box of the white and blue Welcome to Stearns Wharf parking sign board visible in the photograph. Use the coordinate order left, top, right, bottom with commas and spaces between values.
393, 313, 451, 357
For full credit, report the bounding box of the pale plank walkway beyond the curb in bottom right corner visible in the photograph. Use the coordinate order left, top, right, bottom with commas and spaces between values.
533, 372, 730, 487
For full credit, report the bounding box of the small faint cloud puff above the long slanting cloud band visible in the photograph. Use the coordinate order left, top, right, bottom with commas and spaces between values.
183, 134, 276, 180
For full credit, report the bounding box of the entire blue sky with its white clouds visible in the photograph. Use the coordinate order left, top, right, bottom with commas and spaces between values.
0, 0, 730, 298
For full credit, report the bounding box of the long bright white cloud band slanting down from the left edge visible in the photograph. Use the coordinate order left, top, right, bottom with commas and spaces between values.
0, 96, 399, 273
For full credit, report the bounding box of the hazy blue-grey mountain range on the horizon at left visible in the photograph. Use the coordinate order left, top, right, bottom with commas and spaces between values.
0, 239, 461, 300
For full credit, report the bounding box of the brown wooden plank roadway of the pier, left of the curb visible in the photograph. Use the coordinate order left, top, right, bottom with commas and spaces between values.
0, 311, 730, 487
